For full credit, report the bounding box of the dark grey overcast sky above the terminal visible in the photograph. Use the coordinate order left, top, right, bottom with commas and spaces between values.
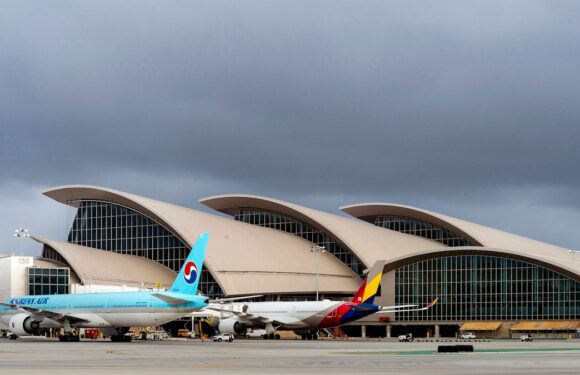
0, 0, 580, 254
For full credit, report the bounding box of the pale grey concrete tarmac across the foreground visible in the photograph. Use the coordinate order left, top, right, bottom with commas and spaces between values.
0, 338, 580, 375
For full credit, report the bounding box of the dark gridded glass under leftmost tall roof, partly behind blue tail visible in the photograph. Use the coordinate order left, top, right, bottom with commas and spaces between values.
68, 201, 224, 298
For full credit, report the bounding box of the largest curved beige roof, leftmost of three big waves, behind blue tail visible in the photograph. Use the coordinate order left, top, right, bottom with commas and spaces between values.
44, 185, 360, 296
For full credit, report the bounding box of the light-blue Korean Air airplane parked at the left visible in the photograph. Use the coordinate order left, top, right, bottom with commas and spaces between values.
0, 233, 209, 341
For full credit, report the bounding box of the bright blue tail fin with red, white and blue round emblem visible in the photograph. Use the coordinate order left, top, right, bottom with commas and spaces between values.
169, 233, 209, 294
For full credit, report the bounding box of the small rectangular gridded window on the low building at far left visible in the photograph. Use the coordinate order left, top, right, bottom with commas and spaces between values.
26, 267, 70, 296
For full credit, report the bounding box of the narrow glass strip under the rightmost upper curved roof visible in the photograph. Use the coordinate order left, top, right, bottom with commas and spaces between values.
374, 216, 478, 247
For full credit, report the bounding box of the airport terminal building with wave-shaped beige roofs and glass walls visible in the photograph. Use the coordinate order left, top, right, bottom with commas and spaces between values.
13, 185, 580, 337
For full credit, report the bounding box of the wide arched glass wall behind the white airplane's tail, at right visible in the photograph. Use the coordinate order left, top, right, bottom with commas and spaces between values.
395, 255, 580, 321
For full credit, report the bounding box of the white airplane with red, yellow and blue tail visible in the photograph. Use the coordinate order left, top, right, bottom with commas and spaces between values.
207, 262, 437, 340
